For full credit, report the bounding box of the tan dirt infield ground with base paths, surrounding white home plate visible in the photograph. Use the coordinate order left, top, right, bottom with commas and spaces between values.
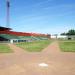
0, 41, 75, 75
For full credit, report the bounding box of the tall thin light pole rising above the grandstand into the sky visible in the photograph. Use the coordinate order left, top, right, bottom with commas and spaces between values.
6, 0, 10, 28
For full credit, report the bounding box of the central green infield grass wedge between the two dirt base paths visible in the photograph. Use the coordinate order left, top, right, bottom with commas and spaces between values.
16, 40, 51, 52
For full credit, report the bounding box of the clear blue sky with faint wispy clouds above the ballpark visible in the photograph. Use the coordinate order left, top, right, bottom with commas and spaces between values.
0, 0, 75, 34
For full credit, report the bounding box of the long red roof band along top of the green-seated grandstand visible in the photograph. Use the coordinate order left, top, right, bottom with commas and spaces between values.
0, 27, 50, 36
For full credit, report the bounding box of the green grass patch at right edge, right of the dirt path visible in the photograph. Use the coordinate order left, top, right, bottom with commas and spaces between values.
59, 40, 75, 52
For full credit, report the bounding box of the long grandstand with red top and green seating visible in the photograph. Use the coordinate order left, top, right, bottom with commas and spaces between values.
0, 27, 50, 43
